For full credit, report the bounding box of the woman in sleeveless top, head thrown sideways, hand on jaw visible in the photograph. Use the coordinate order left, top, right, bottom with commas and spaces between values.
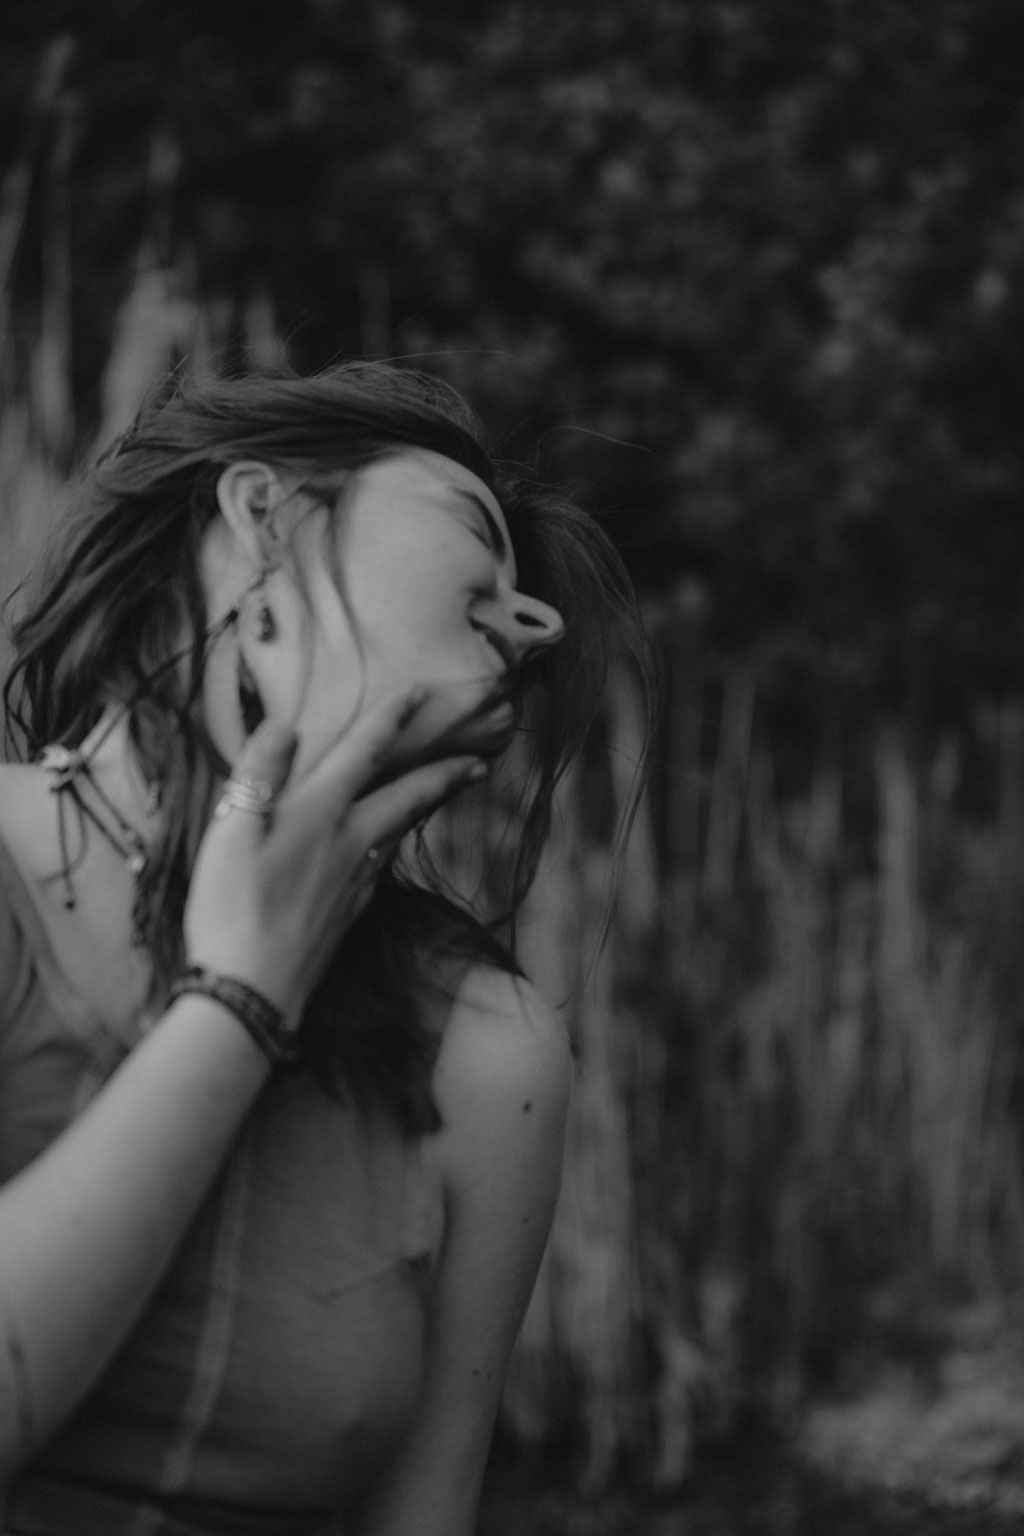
0, 364, 654, 1536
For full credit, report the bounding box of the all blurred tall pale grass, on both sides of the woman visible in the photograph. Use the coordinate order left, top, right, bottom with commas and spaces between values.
0, 158, 1024, 1490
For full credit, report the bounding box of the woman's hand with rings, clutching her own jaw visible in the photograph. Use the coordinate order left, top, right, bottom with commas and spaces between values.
184, 688, 487, 1025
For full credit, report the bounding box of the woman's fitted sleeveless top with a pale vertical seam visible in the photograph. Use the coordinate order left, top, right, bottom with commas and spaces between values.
0, 842, 444, 1536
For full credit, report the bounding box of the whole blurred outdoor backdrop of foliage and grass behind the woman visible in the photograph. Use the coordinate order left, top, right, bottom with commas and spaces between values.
0, 0, 1024, 1536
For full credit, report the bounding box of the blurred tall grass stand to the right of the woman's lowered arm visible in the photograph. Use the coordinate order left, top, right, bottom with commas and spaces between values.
506, 668, 1024, 1481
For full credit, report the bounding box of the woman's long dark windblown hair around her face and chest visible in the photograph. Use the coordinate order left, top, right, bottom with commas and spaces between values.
3, 364, 651, 1132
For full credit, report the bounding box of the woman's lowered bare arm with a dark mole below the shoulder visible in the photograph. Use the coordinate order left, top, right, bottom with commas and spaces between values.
356, 969, 571, 1536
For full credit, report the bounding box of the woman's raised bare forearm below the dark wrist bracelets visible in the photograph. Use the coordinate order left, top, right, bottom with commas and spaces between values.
0, 997, 267, 1485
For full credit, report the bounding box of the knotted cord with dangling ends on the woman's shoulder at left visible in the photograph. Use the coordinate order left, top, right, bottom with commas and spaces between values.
38, 707, 160, 946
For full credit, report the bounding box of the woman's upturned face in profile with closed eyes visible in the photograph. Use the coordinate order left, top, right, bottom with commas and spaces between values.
208, 449, 563, 773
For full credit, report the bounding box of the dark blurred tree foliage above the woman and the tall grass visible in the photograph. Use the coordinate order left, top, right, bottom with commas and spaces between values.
0, 0, 1024, 719
